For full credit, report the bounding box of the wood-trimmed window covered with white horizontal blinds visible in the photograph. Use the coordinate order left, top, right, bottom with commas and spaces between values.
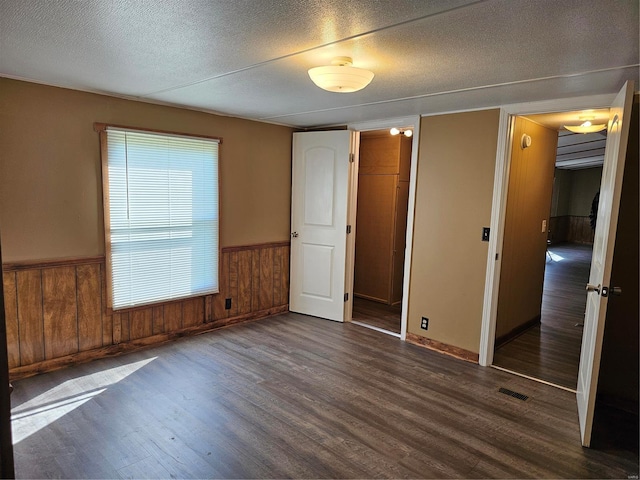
101, 126, 219, 310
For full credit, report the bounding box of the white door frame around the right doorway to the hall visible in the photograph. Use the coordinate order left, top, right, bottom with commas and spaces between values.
478, 93, 616, 367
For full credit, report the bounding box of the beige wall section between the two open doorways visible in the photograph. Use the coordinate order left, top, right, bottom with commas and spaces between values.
408, 110, 499, 353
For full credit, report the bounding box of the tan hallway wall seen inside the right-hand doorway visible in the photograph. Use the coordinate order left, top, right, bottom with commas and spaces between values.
496, 117, 558, 338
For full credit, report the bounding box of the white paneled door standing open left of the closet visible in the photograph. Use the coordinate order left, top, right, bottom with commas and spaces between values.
289, 130, 352, 322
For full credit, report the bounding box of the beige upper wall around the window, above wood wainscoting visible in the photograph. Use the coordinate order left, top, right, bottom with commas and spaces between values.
0, 78, 292, 262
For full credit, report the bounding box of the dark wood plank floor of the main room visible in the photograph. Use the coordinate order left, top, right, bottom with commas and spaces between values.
12, 313, 638, 478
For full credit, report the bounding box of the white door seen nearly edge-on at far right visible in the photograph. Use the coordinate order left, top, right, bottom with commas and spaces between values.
576, 82, 638, 447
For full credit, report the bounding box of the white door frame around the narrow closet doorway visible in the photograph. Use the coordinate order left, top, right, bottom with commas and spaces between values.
344, 115, 420, 341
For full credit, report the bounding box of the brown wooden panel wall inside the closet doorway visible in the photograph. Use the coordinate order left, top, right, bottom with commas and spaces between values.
354, 131, 411, 305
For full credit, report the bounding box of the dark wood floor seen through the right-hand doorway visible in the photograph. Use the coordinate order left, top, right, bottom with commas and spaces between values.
493, 244, 592, 390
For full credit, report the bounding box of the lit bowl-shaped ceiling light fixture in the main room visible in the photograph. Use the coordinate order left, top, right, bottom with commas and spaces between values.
309, 57, 373, 93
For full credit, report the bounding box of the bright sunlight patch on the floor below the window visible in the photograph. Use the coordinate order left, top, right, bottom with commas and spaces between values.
11, 357, 157, 445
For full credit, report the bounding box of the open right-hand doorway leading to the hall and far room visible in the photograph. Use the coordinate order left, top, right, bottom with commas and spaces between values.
493, 109, 608, 391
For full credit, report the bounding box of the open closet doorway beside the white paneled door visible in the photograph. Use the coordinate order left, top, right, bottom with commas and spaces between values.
344, 124, 413, 337
